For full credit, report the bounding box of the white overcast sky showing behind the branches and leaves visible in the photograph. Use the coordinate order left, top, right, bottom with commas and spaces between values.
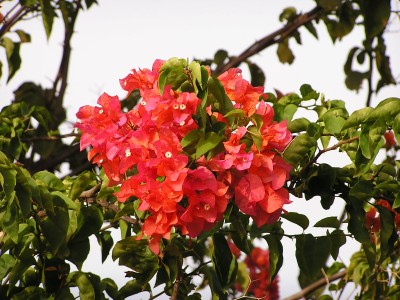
0, 0, 400, 299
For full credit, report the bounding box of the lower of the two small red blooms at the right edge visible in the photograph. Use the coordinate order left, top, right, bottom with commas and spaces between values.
365, 199, 400, 243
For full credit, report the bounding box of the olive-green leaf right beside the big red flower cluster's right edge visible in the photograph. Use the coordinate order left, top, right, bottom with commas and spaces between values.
283, 133, 317, 167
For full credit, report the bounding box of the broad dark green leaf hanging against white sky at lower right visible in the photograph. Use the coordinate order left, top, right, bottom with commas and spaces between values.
296, 234, 331, 277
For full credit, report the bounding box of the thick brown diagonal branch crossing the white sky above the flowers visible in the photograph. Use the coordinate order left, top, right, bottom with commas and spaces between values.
215, 6, 324, 74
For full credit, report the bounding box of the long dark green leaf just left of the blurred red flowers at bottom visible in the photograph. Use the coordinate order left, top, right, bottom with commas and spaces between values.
211, 233, 238, 289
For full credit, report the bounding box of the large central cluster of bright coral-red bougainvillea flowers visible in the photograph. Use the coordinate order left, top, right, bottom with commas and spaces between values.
76, 60, 291, 253
